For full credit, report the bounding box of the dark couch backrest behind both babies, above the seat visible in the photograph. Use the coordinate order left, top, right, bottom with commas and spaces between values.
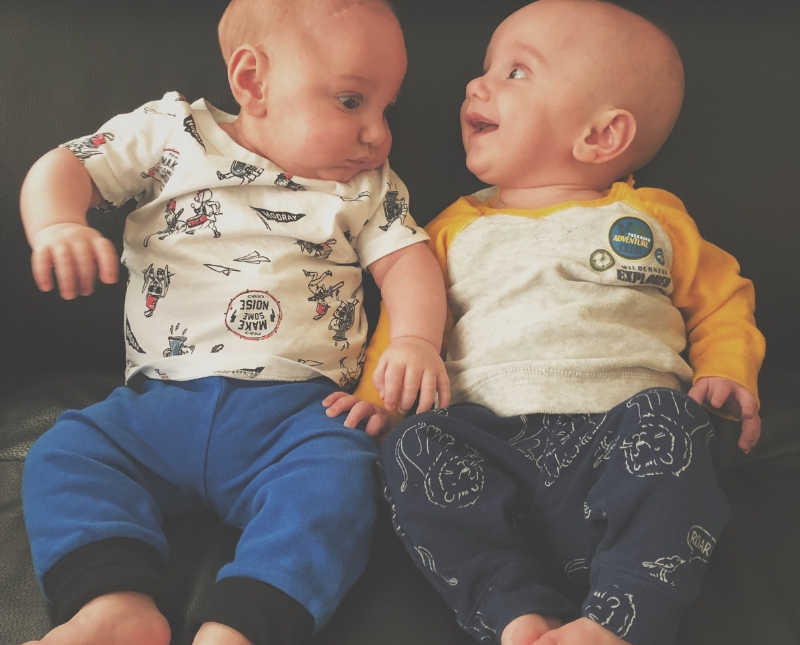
0, 0, 800, 384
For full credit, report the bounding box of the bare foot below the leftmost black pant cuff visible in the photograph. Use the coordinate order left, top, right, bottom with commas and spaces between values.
19, 592, 170, 645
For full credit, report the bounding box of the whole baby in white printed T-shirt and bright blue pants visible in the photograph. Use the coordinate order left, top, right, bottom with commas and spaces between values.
21, 0, 447, 645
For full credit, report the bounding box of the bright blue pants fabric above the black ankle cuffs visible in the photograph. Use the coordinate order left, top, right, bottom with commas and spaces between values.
23, 377, 377, 642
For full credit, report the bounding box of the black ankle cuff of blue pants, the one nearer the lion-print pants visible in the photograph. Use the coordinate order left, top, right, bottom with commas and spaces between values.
200, 577, 314, 645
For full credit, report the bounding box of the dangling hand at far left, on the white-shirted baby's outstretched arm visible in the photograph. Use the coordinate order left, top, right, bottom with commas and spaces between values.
31, 222, 119, 300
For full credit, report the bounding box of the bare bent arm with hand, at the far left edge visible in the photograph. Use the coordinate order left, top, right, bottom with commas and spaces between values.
20, 148, 119, 300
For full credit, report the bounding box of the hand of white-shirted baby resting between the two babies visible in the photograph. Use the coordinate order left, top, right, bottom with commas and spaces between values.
372, 336, 450, 414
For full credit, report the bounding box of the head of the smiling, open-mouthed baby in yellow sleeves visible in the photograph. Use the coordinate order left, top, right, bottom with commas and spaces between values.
461, 0, 684, 188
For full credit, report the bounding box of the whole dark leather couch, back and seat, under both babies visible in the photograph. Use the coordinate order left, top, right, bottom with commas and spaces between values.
0, 0, 800, 645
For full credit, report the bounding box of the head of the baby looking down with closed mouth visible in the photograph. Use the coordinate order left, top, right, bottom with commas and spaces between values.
219, 0, 407, 181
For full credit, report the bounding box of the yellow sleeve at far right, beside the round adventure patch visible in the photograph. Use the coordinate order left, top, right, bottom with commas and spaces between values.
637, 188, 766, 401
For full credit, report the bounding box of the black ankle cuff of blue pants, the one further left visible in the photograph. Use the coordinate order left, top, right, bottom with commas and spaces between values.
42, 538, 164, 625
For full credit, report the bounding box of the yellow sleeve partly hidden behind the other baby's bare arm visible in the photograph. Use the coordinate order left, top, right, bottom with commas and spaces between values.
353, 197, 476, 406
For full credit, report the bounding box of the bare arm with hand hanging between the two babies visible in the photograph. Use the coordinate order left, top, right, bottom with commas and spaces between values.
369, 242, 450, 412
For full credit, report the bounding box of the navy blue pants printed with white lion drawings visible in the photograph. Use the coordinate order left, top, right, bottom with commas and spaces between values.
380, 388, 728, 645
